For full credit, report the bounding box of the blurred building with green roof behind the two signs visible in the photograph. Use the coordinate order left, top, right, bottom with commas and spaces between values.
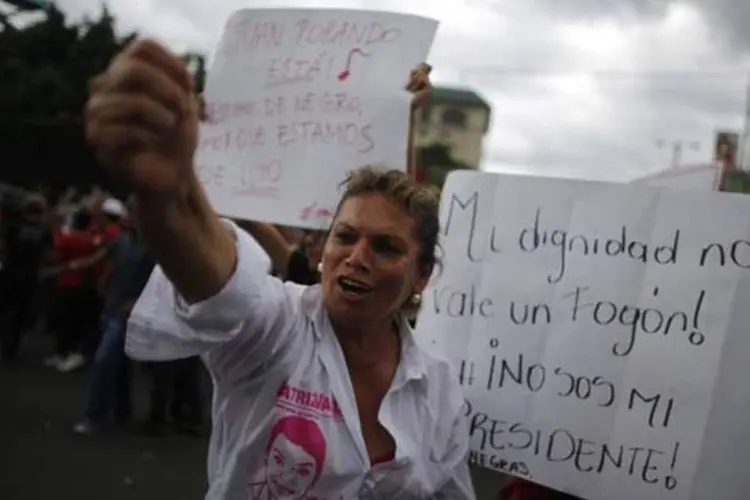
413, 86, 492, 186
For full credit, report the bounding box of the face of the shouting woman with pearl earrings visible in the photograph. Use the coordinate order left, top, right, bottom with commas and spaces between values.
323, 194, 429, 326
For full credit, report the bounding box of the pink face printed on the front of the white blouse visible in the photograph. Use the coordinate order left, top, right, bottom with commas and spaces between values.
266, 434, 316, 500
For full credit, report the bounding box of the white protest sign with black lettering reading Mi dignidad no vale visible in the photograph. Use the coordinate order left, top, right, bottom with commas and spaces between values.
417, 171, 750, 500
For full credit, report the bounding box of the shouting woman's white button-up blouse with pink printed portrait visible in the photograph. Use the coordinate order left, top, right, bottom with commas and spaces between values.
126, 222, 475, 500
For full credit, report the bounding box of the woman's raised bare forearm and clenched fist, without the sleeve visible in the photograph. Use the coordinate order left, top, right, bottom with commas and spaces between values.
86, 40, 237, 303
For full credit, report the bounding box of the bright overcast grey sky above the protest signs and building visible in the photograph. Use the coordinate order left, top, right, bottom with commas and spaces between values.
44, 0, 750, 180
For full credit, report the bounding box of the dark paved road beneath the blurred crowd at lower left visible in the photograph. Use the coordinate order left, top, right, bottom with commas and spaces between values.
0, 336, 212, 500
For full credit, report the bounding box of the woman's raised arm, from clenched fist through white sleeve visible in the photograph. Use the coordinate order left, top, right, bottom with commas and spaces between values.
92, 40, 312, 379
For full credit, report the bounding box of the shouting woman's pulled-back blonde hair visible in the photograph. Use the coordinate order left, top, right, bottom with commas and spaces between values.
336, 165, 440, 314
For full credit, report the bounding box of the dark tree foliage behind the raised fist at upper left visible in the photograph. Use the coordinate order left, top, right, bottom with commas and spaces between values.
0, 6, 205, 193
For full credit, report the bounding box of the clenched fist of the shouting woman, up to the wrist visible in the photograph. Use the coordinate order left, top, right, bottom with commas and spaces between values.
86, 40, 199, 194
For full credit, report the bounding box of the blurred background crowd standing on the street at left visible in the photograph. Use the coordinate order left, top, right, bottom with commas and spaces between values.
0, 188, 205, 434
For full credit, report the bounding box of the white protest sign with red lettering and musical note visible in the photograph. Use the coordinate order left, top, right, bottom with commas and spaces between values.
196, 9, 437, 228
